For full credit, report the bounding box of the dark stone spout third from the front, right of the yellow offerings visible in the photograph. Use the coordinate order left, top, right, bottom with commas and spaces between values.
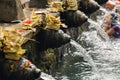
60, 10, 87, 27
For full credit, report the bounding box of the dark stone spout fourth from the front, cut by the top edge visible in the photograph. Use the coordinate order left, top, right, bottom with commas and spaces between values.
78, 0, 99, 14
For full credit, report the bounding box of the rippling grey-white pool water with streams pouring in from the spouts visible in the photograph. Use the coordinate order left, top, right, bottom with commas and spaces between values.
54, 6, 120, 80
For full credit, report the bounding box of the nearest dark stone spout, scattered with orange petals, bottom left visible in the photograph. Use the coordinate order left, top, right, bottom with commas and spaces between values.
0, 58, 41, 80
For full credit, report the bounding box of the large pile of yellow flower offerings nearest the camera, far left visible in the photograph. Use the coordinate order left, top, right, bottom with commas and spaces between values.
3, 30, 26, 59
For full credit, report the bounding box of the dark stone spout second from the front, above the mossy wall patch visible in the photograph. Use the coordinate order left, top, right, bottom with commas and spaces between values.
36, 30, 71, 50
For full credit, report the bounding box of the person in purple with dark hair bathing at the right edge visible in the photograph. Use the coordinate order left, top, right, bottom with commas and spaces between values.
103, 5, 120, 38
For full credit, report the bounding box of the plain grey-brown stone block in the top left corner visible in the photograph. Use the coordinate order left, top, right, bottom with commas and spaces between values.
0, 0, 24, 22
